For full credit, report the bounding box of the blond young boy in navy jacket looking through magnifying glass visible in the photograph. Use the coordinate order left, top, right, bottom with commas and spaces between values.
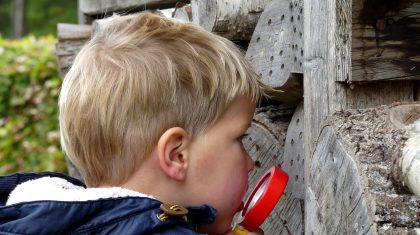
0, 13, 265, 234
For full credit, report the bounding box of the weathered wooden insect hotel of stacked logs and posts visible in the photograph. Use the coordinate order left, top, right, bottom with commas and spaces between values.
56, 0, 420, 234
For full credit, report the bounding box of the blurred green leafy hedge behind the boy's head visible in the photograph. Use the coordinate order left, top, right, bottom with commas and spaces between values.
0, 37, 66, 174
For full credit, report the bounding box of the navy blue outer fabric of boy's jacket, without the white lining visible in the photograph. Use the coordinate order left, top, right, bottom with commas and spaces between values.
0, 173, 216, 234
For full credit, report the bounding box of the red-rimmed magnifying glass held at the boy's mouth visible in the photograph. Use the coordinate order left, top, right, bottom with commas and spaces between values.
233, 166, 289, 234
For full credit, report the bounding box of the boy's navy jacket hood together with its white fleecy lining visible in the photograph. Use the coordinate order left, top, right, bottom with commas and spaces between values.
0, 173, 216, 234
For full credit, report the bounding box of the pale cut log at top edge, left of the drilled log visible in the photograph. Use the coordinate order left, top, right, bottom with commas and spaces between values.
191, 0, 270, 41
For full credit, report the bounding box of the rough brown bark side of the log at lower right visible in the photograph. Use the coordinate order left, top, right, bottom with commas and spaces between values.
324, 103, 420, 234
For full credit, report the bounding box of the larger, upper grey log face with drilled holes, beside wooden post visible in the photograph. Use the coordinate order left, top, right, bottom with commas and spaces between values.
246, 0, 303, 101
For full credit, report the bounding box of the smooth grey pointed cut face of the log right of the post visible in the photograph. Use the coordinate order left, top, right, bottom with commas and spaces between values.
305, 126, 376, 234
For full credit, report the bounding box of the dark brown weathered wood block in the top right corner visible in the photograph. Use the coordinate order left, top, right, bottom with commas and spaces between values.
350, 0, 420, 82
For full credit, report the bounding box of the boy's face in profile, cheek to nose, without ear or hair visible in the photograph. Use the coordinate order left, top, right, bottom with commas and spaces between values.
187, 96, 255, 234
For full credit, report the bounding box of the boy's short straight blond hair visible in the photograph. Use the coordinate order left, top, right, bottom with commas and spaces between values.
59, 13, 263, 186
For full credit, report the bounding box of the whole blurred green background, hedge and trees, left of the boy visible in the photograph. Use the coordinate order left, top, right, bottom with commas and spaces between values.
0, 0, 77, 175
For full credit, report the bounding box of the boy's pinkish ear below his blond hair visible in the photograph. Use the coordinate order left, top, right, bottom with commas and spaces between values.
157, 127, 189, 181
